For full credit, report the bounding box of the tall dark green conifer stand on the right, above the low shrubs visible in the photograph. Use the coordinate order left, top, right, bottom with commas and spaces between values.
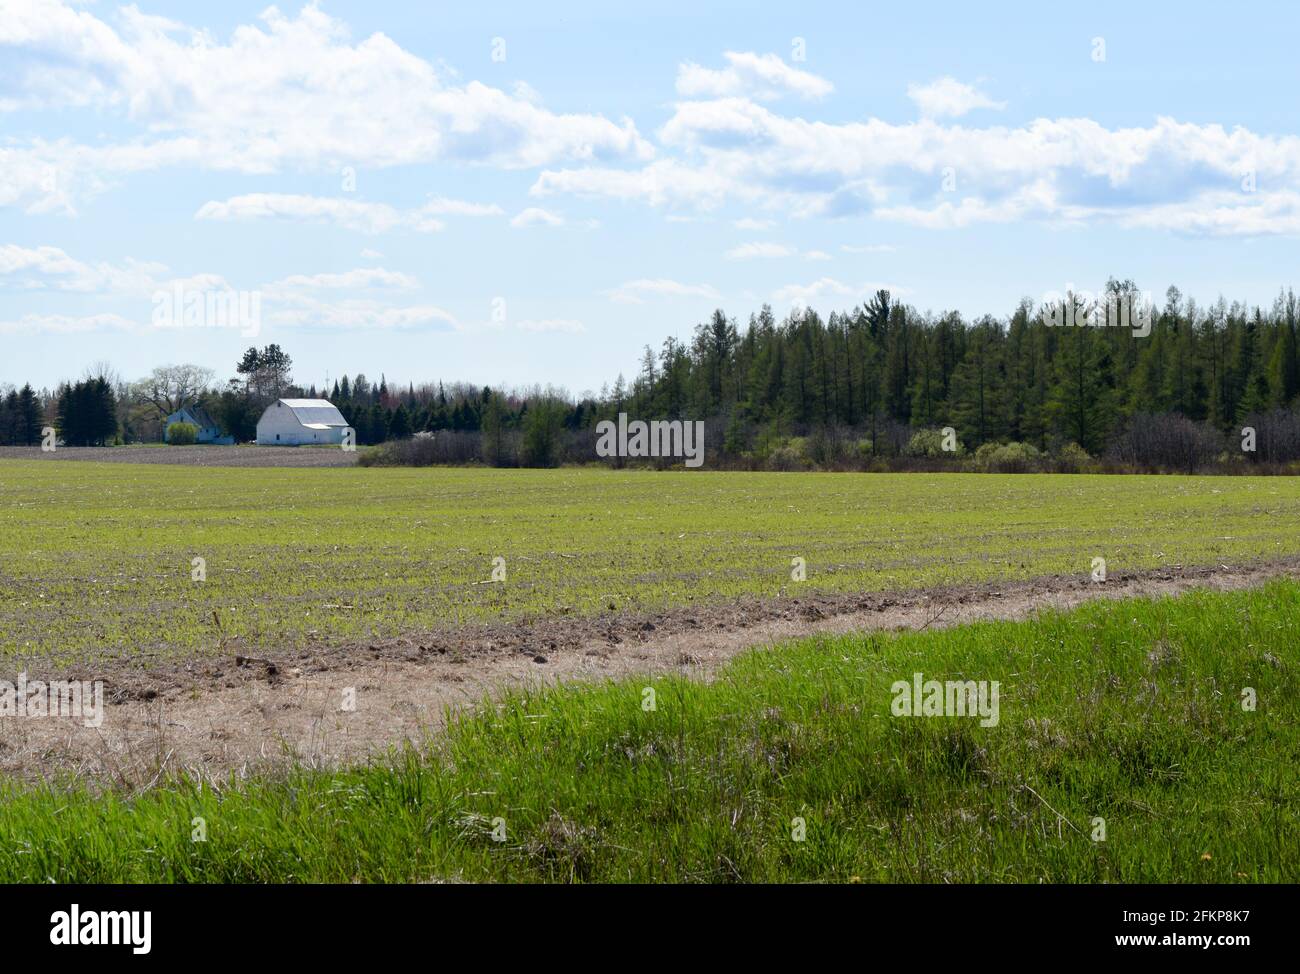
611, 281, 1300, 455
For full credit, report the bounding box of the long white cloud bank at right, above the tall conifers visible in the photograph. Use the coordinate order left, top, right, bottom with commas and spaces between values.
532, 98, 1300, 234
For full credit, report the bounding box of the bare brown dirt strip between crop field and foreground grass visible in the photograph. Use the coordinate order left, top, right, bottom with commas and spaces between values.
0, 558, 1300, 788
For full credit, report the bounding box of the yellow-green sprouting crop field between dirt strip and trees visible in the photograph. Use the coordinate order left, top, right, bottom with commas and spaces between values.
0, 460, 1300, 661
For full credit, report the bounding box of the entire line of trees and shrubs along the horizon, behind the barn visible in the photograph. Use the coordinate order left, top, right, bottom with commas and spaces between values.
0, 280, 1300, 469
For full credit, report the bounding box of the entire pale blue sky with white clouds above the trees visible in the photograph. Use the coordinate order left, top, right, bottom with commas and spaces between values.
0, 0, 1300, 393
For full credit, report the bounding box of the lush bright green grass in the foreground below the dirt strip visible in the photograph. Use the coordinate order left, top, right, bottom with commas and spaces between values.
0, 583, 1300, 882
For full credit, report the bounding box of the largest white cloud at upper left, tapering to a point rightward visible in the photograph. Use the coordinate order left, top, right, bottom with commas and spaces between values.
0, 0, 653, 209
